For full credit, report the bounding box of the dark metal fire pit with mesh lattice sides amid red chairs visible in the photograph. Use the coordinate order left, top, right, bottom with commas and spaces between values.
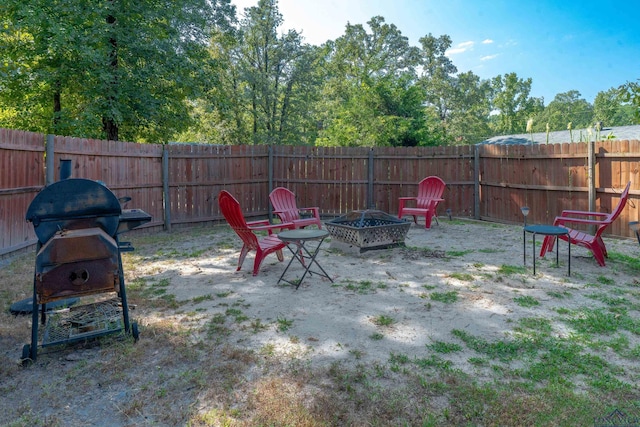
325, 210, 411, 253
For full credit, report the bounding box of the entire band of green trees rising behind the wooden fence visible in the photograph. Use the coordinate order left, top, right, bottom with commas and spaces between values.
0, 0, 640, 146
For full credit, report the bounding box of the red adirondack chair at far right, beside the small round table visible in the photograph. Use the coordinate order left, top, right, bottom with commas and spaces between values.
540, 181, 631, 267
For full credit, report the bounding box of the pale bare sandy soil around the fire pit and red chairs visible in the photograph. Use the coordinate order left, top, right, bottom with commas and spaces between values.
119, 218, 640, 375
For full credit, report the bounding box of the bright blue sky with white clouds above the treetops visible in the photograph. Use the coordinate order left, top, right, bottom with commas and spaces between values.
232, 0, 640, 105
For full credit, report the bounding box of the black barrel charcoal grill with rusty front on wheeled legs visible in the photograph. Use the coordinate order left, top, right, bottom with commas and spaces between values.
22, 178, 151, 361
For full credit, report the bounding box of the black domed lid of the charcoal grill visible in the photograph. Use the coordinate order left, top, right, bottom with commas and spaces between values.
26, 178, 122, 243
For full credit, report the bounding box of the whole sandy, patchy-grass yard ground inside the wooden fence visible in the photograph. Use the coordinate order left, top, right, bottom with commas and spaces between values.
0, 218, 640, 426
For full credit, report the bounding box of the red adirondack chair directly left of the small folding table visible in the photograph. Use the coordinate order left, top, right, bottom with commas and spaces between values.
218, 190, 293, 276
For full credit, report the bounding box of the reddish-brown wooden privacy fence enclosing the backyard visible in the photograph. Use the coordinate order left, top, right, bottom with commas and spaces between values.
0, 129, 640, 255
